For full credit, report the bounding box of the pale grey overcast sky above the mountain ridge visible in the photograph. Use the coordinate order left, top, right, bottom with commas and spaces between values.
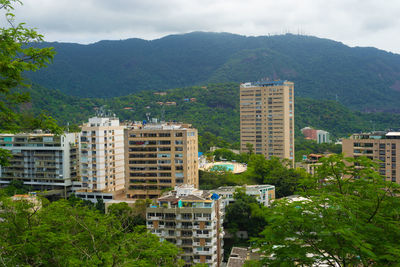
4, 0, 400, 53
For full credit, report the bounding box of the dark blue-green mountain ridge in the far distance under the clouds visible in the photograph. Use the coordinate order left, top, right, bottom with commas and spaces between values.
29, 32, 400, 112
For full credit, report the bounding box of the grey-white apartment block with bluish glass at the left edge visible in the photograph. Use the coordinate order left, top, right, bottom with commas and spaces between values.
0, 131, 80, 195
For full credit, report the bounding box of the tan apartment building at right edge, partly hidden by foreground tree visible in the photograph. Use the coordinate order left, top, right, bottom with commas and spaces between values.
342, 132, 400, 184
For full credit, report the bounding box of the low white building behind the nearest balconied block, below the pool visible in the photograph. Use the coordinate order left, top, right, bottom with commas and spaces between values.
210, 184, 275, 208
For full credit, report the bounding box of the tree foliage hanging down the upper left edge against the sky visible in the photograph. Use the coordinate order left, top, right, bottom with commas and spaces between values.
0, 0, 60, 165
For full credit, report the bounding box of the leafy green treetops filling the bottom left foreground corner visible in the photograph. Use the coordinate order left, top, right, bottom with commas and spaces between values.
0, 197, 182, 267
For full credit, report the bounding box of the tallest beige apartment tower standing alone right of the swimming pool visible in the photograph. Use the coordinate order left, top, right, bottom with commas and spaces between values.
240, 81, 294, 166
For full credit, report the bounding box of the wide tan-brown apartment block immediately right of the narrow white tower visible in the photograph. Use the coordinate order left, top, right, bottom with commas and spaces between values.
125, 123, 199, 199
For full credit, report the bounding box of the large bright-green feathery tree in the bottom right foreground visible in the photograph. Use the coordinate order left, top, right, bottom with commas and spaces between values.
257, 155, 400, 266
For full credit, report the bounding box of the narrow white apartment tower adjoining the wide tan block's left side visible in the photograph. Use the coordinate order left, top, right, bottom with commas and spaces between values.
75, 117, 125, 195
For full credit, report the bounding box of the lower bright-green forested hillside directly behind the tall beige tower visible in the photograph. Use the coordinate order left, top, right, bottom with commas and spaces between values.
27, 83, 400, 143
